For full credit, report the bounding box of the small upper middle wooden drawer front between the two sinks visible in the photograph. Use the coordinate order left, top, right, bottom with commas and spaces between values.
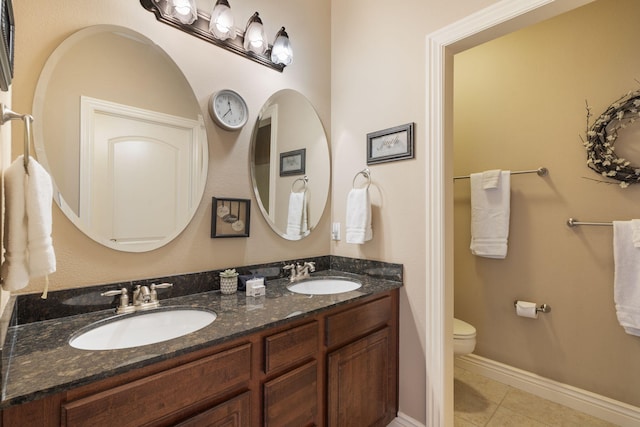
264, 321, 318, 374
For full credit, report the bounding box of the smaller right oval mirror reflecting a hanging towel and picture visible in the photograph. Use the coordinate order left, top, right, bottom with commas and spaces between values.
250, 89, 331, 240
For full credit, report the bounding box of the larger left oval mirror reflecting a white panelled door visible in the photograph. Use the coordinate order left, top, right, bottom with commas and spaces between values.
33, 25, 208, 252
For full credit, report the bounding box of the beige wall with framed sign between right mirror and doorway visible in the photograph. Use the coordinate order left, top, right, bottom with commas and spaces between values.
331, 0, 494, 423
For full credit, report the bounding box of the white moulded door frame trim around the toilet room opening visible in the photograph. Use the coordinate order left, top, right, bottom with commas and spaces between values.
425, 0, 594, 427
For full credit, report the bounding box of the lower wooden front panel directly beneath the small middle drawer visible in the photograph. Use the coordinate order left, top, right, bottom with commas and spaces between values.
264, 360, 318, 427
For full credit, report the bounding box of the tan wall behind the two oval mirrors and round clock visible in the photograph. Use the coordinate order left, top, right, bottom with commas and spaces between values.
13, 0, 331, 292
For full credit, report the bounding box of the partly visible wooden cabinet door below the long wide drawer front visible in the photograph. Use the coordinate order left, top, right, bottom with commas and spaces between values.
176, 392, 252, 427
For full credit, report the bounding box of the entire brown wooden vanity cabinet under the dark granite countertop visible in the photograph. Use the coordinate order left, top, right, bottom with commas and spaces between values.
0, 289, 398, 427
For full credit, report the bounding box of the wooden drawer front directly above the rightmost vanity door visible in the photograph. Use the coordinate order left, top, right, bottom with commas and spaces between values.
327, 296, 392, 347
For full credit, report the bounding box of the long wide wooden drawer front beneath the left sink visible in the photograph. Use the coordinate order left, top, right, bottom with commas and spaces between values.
62, 344, 251, 427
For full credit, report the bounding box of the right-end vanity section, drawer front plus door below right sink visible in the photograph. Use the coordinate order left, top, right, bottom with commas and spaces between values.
326, 293, 398, 427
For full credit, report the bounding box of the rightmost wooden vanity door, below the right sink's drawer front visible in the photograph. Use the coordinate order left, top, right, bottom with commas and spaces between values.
327, 327, 395, 427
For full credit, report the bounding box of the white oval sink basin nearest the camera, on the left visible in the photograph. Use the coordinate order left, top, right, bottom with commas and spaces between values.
69, 307, 217, 350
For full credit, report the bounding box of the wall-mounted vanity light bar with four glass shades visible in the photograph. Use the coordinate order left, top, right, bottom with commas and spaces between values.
140, 0, 293, 72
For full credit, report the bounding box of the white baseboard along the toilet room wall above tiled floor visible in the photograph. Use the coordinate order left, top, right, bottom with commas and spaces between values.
456, 354, 640, 427
